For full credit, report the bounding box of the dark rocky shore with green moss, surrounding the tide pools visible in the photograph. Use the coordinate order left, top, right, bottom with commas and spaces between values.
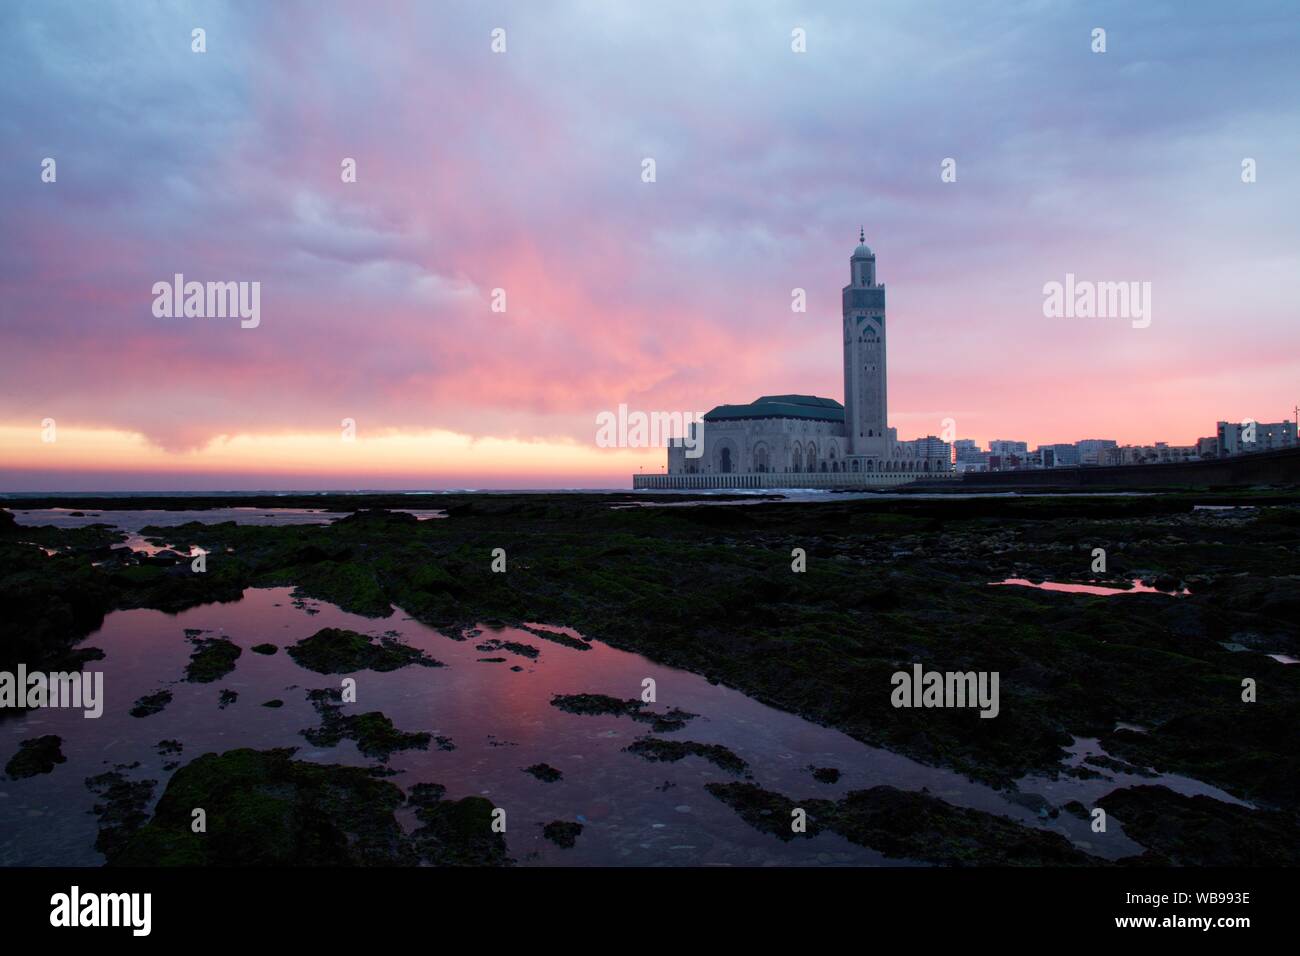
0, 493, 1300, 865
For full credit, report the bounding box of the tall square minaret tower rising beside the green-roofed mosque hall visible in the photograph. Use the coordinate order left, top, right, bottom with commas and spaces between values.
844, 230, 889, 458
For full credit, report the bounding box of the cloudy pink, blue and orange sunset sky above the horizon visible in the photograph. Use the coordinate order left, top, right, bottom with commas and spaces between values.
0, 0, 1300, 492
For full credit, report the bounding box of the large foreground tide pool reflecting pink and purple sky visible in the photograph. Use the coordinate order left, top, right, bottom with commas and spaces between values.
0, 588, 1230, 865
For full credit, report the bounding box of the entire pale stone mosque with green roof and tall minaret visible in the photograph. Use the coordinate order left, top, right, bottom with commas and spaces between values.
632, 232, 953, 489
